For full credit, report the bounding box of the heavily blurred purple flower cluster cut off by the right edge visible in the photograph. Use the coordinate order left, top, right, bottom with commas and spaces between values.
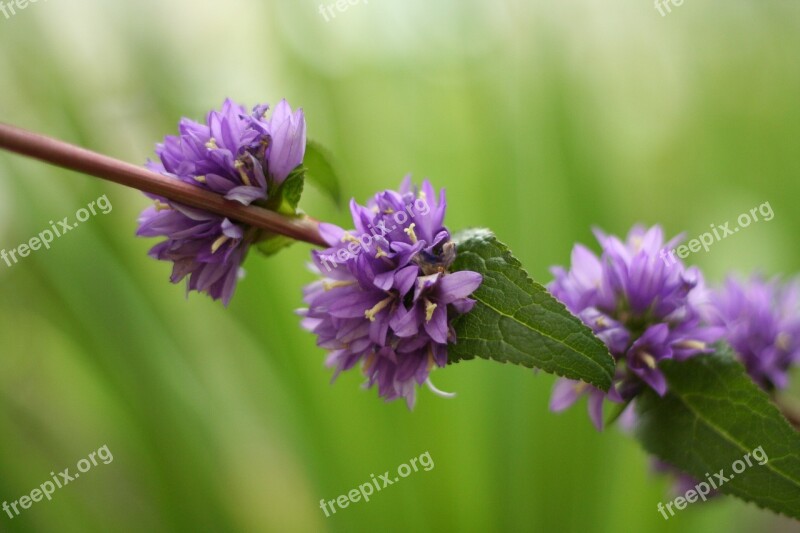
708, 276, 800, 391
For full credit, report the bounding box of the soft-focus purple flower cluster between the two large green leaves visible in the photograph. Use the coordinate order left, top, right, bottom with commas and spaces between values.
549, 226, 720, 429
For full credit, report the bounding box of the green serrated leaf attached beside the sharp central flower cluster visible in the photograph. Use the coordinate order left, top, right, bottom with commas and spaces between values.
448, 229, 615, 390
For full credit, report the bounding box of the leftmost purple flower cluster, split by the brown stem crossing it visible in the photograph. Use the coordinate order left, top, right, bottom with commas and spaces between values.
137, 100, 306, 305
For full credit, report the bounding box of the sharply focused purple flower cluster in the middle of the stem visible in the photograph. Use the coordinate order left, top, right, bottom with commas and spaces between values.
299, 178, 483, 408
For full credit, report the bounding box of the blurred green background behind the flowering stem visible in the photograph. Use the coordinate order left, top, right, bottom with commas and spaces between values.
0, 0, 800, 532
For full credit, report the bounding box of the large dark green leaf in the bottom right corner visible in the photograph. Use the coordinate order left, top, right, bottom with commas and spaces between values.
636, 349, 800, 519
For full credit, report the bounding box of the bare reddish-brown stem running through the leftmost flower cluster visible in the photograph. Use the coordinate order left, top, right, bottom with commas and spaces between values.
0, 123, 327, 247
